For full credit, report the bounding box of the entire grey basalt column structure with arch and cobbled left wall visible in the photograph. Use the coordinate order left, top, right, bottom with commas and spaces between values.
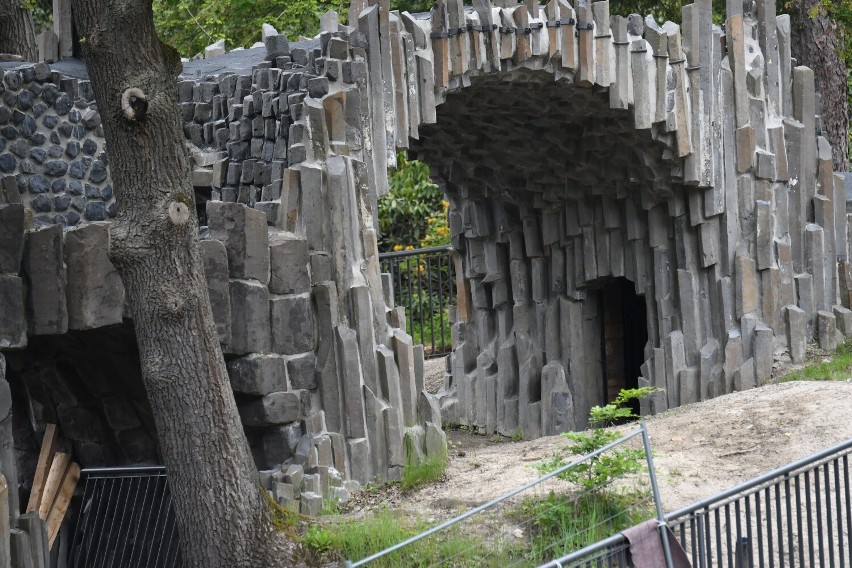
0, 0, 852, 512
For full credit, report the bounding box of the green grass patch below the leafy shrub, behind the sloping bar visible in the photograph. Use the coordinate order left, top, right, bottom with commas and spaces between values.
509, 491, 654, 566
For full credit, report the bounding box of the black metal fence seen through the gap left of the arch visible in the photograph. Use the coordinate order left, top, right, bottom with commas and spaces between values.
379, 246, 456, 357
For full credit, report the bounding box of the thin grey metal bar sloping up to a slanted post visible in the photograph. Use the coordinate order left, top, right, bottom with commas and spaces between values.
345, 422, 671, 568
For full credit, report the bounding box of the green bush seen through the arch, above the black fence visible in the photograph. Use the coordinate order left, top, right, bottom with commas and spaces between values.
379, 152, 449, 252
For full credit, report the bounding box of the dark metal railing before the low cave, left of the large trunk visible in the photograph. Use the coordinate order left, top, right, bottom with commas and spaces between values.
67, 467, 183, 568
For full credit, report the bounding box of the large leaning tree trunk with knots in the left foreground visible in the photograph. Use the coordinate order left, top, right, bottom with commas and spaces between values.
73, 0, 288, 568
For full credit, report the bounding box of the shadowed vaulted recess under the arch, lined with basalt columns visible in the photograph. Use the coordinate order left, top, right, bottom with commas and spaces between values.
411, 70, 685, 438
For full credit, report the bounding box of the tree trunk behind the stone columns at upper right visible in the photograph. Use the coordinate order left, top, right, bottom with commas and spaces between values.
790, 0, 849, 172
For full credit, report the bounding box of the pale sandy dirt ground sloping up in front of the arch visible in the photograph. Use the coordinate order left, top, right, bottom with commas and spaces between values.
346, 379, 852, 519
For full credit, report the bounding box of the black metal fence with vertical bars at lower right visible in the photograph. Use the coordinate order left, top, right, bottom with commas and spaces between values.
546, 439, 852, 568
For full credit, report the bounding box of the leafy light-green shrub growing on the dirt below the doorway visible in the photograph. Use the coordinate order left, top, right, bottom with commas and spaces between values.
537, 387, 657, 493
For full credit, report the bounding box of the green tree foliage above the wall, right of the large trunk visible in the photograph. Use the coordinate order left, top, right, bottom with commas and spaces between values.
154, 0, 349, 57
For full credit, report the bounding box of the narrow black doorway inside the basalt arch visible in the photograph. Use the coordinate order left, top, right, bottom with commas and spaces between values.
600, 278, 648, 404
